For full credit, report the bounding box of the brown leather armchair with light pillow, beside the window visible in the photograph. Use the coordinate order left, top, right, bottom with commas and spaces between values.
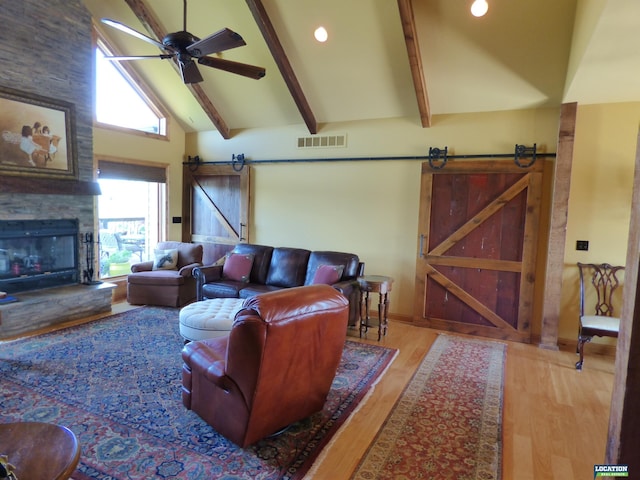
127, 242, 202, 307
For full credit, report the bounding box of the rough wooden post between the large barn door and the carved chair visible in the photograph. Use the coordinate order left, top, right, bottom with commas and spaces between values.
540, 103, 578, 350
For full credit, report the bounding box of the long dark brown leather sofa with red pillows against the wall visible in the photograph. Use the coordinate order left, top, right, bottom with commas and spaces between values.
193, 243, 364, 326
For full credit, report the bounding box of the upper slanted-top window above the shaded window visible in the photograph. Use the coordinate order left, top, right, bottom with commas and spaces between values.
95, 37, 167, 136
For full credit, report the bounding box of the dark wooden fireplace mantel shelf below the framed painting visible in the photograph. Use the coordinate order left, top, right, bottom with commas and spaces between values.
0, 175, 101, 195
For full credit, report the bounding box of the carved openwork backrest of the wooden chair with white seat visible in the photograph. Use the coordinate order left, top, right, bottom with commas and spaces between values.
578, 262, 624, 317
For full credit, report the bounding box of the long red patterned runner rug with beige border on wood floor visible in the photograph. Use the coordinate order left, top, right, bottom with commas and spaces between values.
352, 335, 506, 480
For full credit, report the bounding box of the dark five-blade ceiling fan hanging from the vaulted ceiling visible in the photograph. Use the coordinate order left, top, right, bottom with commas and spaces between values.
102, 0, 265, 83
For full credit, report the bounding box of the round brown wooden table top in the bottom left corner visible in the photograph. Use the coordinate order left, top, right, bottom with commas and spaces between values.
0, 422, 80, 480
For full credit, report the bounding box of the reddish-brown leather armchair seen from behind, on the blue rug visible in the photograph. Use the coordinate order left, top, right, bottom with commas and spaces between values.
182, 285, 348, 447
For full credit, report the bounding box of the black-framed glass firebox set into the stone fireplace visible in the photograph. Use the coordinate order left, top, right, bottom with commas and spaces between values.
0, 219, 79, 293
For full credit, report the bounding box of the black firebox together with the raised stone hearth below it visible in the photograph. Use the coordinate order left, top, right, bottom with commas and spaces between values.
0, 218, 114, 340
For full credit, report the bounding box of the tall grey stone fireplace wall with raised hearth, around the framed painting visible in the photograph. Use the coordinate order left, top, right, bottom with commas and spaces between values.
0, 0, 113, 339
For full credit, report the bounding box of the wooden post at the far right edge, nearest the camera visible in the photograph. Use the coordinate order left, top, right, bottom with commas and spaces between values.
605, 127, 640, 468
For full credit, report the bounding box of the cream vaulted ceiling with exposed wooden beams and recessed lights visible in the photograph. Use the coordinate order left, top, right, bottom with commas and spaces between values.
83, 0, 640, 138
